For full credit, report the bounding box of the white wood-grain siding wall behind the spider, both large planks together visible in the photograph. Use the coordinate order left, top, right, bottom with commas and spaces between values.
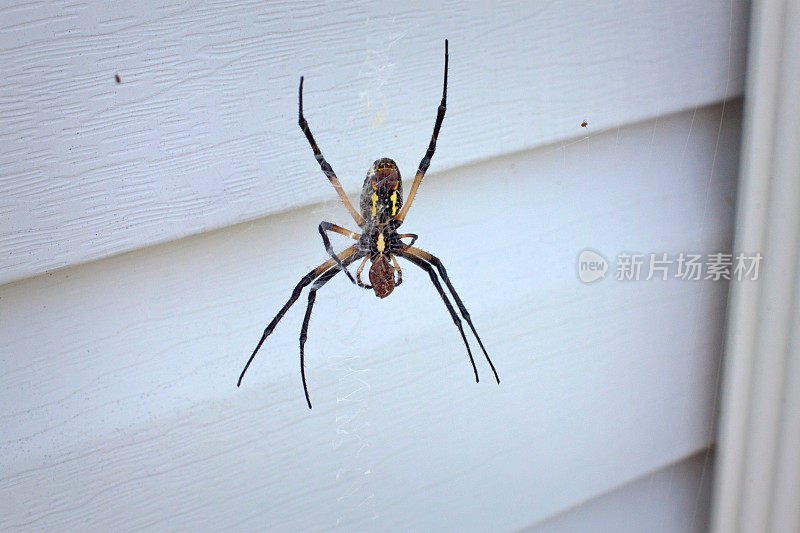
0, 2, 746, 530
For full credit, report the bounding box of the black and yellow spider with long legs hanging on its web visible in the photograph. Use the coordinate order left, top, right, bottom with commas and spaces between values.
237, 39, 500, 409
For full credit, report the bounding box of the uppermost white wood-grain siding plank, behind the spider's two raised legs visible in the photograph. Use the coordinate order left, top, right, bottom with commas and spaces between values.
0, 0, 747, 283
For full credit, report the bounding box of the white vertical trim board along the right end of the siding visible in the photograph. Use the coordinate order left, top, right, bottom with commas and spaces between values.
714, 0, 800, 533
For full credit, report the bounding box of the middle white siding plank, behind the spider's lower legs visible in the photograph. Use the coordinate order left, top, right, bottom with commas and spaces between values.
0, 102, 740, 530
